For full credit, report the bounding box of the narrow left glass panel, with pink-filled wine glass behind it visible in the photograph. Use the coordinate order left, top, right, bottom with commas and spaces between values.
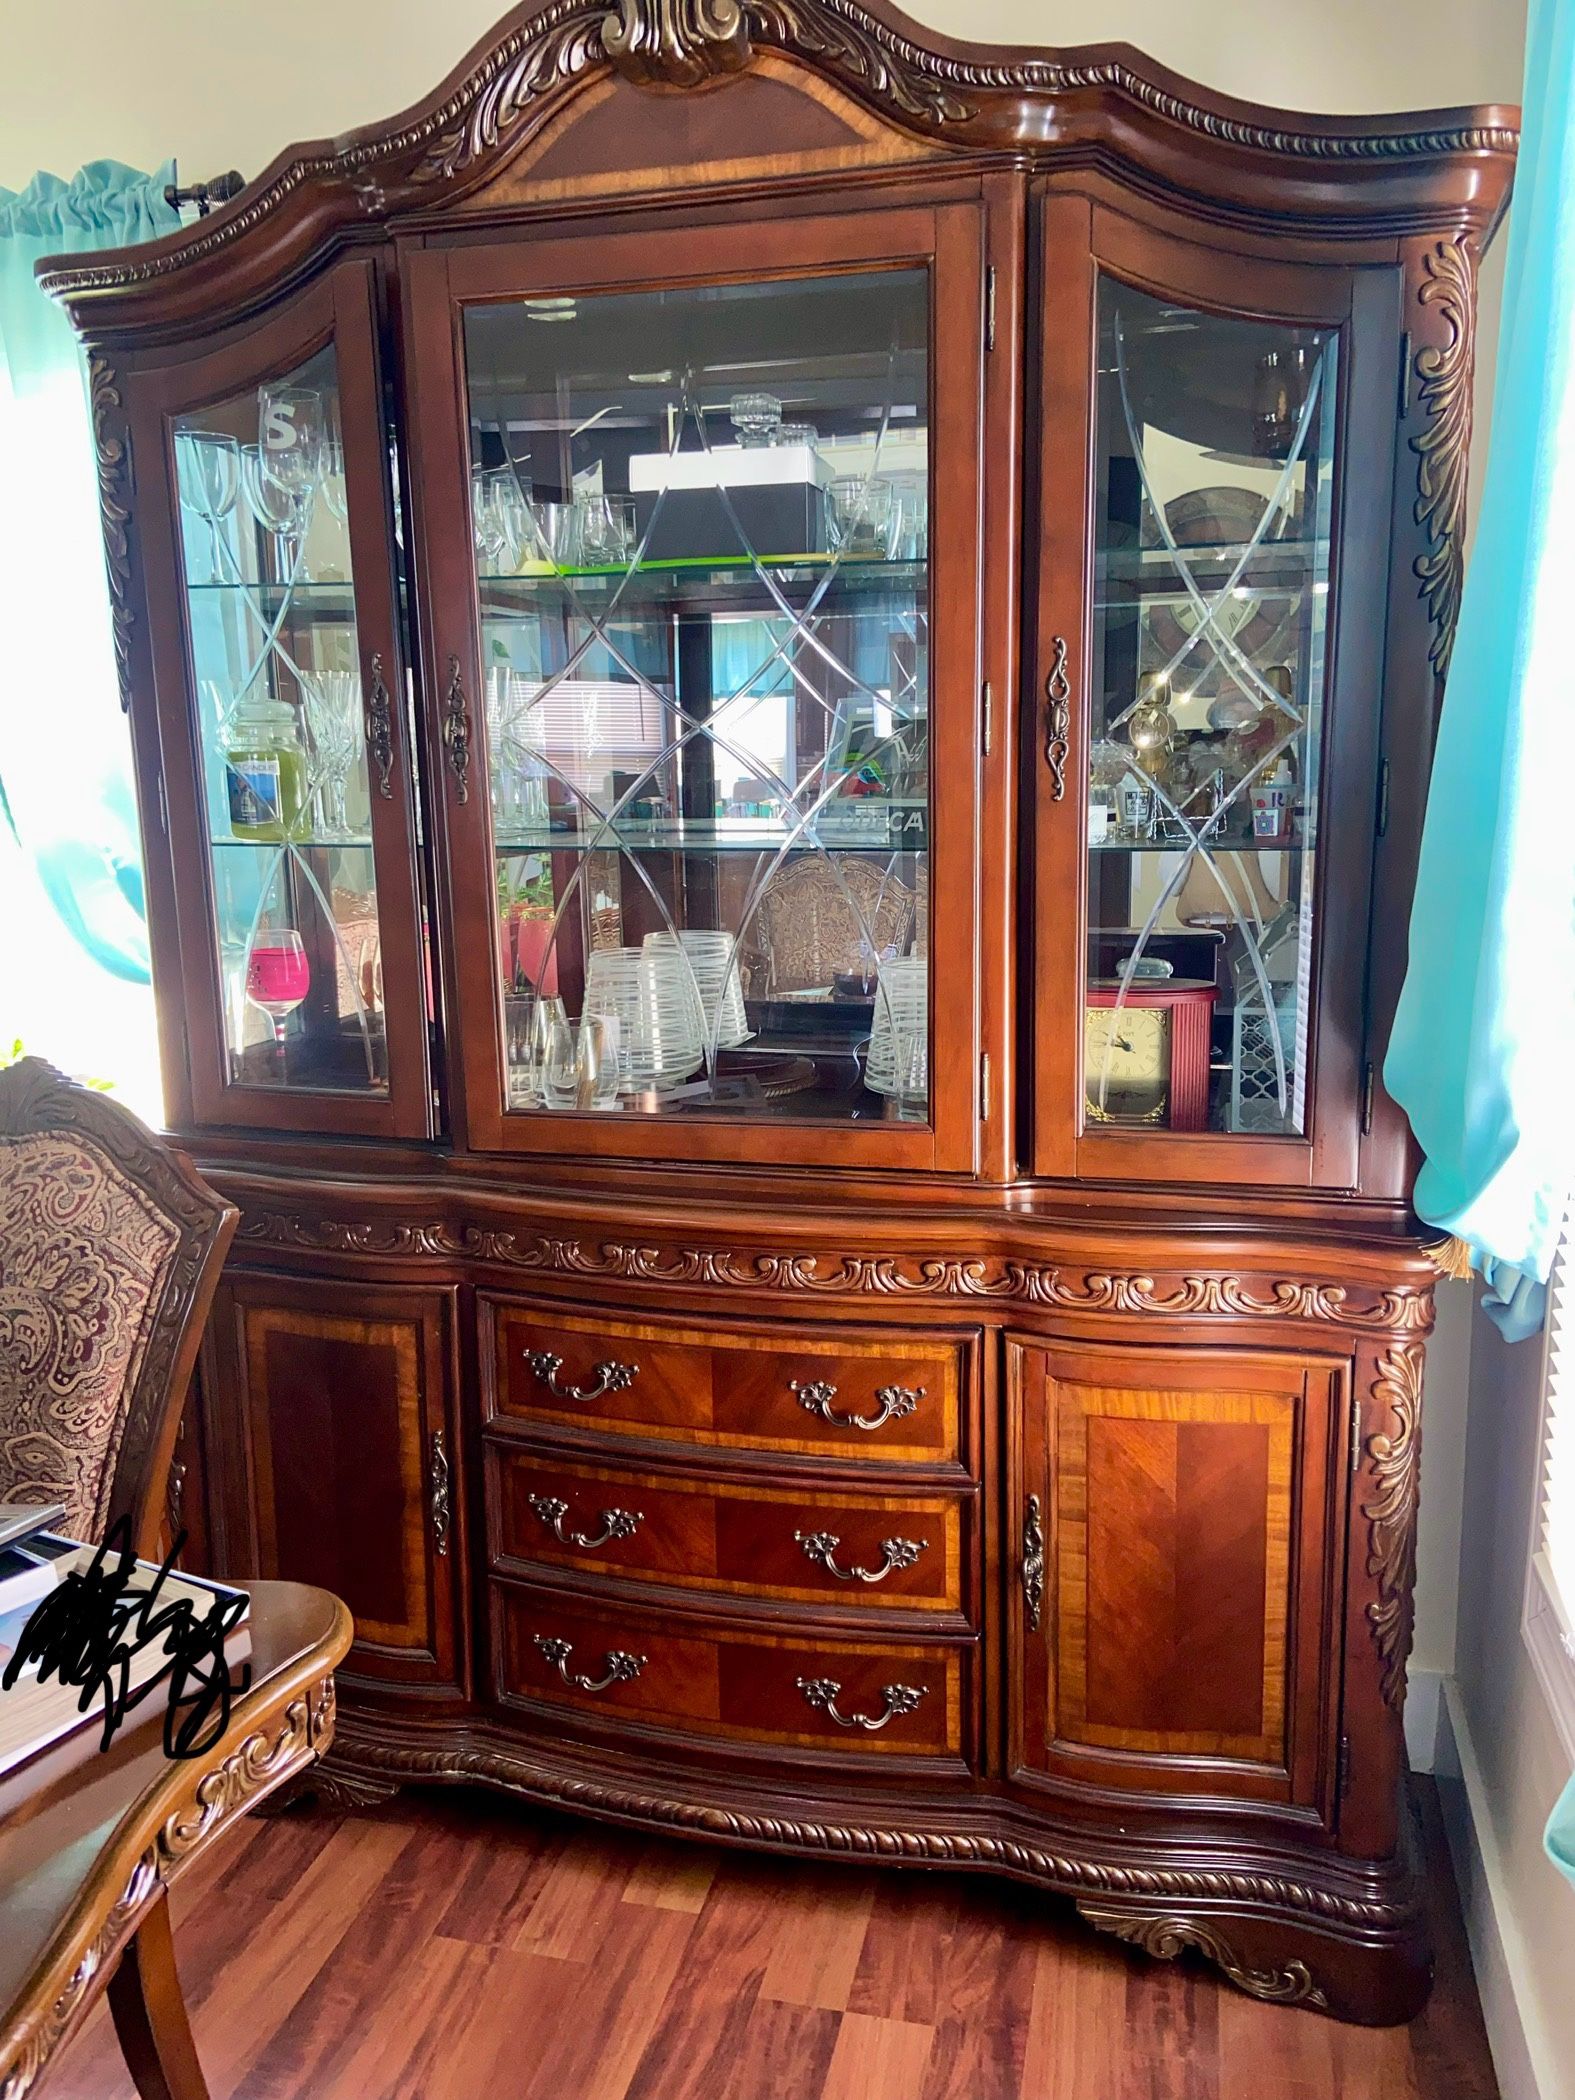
172, 344, 389, 1094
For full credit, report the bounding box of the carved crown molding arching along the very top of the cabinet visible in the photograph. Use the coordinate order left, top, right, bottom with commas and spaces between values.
42, 0, 1518, 296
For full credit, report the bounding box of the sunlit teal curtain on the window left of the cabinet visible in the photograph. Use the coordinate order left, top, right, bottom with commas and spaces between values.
0, 160, 179, 983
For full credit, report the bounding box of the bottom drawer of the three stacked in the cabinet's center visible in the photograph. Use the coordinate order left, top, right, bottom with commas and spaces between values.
491, 1581, 972, 1764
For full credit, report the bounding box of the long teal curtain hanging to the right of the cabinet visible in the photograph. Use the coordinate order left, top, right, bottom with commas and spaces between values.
1384, 0, 1575, 1338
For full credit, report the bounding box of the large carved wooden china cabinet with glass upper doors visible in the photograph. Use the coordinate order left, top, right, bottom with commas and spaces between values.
46, 0, 1516, 2020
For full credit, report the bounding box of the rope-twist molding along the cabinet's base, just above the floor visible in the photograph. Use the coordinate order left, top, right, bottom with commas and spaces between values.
323, 1730, 1422, 1932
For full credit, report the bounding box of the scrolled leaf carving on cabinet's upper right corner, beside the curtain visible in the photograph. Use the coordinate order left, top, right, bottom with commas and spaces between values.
1411, 233, 1476, 680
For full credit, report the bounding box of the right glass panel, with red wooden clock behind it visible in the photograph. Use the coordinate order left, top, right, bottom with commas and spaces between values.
1082, 277, 1338, 1136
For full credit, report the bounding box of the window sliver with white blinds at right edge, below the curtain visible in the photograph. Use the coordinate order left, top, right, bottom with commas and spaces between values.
1527, 1224, 1575, 1758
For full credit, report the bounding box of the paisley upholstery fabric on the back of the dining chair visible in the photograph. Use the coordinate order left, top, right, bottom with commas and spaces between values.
0, 1132, 179, 1539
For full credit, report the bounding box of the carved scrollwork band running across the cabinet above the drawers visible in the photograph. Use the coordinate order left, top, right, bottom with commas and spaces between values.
239, 1210, 1432, 1334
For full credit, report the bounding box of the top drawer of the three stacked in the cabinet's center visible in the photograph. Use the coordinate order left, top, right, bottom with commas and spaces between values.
483, 1300, 962, 1464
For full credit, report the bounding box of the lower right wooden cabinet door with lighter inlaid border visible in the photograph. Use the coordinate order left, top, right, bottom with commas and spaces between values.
1010, 1342, 1348, 1814
